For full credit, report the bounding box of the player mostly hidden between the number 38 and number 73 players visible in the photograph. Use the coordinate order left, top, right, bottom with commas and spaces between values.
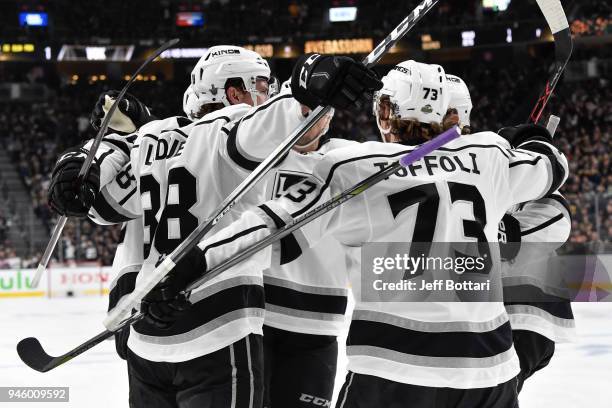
251, 82, 356, 408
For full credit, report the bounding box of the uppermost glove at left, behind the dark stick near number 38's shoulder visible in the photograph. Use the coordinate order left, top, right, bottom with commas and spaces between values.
89, 91, 157, 133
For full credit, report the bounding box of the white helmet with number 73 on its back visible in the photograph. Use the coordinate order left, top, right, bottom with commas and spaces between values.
373, 60, 448, 135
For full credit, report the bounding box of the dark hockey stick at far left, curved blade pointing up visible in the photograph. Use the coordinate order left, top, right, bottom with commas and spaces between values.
31, 38, 179, 288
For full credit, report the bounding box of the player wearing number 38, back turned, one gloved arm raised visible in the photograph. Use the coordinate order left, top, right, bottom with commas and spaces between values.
49, 46, 378, 406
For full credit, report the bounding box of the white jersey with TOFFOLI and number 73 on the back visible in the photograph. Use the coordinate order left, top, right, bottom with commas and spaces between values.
194, 132, 567, 388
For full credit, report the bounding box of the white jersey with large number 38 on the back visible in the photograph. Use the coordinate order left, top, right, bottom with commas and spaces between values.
88, 94, 304, 362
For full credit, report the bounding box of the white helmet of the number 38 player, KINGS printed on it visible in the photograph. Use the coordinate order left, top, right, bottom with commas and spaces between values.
191, 45, 270, 110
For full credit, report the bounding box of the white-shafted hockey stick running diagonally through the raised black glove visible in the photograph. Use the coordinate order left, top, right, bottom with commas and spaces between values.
104, 0, 439, 328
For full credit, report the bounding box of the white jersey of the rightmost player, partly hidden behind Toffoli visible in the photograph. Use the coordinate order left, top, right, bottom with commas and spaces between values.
502, 192, 576, 342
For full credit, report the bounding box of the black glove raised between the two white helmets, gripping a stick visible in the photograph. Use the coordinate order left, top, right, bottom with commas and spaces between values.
291, 54, 383, 109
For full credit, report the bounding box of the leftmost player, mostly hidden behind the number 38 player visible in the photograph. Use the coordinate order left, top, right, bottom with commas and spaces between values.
48, 91, 158, 360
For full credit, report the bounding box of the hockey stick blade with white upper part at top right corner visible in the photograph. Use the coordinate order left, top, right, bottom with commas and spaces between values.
529, 0, 573, 123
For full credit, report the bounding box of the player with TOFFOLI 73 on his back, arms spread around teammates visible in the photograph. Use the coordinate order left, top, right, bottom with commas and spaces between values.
151, 61, 567, 408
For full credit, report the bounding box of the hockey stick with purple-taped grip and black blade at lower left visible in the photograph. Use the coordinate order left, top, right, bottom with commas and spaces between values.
17, 126, 461, 373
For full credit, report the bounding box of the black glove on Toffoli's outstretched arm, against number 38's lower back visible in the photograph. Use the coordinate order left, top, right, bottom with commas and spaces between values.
140, 247, 206, 330
